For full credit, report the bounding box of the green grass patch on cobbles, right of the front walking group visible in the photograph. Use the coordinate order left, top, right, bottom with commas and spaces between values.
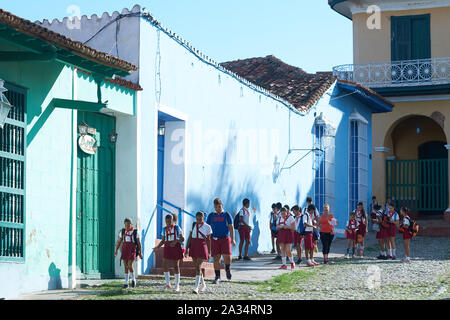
255, 269, 316, 293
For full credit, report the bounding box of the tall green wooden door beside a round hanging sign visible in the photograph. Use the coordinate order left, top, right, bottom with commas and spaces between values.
77, 112, 115, 279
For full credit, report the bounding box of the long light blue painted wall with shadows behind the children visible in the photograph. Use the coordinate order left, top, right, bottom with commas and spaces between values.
139, 20, 371, 272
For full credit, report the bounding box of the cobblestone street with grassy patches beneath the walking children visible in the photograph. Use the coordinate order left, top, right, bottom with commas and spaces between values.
22, 234, 450, 300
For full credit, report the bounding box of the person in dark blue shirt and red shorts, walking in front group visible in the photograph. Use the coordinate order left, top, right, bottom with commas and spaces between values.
206, 199, 236, 284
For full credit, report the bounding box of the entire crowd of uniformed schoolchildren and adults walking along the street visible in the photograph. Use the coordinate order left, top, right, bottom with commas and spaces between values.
115, 197, 418, 294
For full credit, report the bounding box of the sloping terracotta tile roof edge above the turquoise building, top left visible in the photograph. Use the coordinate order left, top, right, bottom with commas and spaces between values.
0, 9, 138, 72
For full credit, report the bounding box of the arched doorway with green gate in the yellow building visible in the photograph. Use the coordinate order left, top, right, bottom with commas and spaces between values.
386, 115, 448, 217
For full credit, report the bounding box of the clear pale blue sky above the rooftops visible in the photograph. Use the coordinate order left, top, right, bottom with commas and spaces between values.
1, 0, 353, 72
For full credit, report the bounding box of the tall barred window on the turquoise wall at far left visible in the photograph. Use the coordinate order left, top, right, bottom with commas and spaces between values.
0, 84, 26, 261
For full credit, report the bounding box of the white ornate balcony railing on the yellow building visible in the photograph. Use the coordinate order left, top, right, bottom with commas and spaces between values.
333, 58, 450, 88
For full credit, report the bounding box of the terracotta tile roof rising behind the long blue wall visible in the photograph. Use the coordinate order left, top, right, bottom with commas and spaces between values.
221, 55, 336, 111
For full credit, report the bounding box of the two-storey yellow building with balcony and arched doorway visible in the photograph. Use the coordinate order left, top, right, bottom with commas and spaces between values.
328, 0, 450, 217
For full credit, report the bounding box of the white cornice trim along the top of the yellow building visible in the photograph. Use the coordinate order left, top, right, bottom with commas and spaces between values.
349, 0, 450, 15
